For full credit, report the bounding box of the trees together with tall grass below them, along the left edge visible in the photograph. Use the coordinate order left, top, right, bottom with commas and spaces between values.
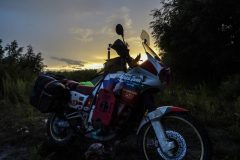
0, 40, 44, 130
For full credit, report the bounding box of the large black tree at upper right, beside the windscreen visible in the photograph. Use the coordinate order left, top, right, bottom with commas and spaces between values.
151, 0, 240, 81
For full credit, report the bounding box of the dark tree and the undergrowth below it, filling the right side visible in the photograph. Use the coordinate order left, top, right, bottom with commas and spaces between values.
150, 0, 240, 159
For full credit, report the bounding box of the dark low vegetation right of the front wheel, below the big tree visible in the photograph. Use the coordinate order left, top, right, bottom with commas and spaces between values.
156, 76, 240, 160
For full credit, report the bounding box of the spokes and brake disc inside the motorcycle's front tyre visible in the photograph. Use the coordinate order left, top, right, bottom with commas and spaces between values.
143, 116, 208, 160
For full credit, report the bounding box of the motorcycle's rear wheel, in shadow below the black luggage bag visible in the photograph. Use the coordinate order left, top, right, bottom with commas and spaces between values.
47, 113, 74, 146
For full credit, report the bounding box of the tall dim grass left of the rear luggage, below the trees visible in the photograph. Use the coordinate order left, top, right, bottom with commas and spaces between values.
0, 72, 38, 131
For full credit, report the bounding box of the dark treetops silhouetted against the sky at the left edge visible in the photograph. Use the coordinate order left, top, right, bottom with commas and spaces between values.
0, 40, 44, 80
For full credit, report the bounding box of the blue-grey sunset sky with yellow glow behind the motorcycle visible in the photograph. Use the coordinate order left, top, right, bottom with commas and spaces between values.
0, 0, 161, 69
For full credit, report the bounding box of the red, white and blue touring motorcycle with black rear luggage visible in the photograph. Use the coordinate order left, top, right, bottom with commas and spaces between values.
30, 24, 211, 160
